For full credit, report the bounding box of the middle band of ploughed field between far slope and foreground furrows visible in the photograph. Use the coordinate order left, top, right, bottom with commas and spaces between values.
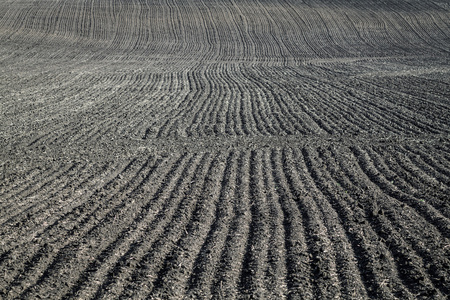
2, 64, 450, 147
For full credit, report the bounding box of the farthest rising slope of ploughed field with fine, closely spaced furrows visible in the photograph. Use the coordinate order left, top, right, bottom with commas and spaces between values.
0, 0, 449, 61
